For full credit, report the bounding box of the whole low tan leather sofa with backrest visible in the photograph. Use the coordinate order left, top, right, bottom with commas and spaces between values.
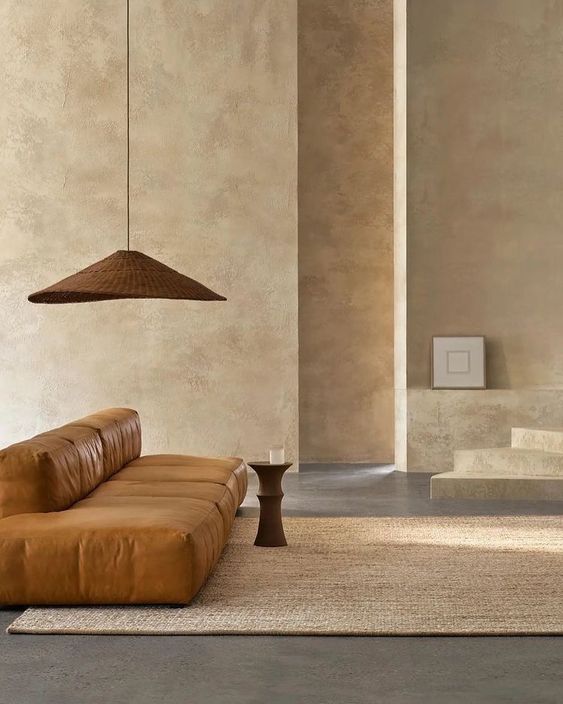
0, 408, 247, 605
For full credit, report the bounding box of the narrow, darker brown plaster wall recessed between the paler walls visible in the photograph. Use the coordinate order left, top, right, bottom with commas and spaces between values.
299, 0, 393, 462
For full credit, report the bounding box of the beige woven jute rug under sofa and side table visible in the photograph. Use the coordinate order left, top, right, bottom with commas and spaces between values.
8, 516, 563, 635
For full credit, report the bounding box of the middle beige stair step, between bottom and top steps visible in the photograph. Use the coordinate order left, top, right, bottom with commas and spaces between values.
454, 447, 563, 477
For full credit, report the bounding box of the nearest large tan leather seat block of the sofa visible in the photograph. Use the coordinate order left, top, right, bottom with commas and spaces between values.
0, 497, 225, 604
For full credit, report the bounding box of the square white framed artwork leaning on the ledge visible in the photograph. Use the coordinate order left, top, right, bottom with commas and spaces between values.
432, 335, 486, 389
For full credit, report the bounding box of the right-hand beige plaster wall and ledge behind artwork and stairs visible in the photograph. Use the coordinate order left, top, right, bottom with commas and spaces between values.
407, 0, 563, 471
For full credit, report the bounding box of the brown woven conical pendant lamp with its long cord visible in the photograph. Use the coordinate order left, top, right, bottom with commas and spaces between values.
28, 0, 227, 303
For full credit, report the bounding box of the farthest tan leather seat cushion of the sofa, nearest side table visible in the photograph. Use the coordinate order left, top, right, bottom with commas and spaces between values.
119, 455, 248, 506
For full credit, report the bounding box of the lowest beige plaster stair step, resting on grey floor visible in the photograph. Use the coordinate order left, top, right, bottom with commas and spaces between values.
430, 472, 563, 501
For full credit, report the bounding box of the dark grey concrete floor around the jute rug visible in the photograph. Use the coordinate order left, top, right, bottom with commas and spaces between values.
0, 465, 563, 704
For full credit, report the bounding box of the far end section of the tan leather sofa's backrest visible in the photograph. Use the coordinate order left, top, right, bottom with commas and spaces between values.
71, 408, 141, 480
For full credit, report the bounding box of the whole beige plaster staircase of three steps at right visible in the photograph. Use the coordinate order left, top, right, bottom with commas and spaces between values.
430, 428, 563, 501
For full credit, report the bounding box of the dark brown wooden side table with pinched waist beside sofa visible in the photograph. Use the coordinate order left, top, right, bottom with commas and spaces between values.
248, 462, 293, 548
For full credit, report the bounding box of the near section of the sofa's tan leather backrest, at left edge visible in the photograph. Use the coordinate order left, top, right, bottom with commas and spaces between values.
0, 426, 104, 518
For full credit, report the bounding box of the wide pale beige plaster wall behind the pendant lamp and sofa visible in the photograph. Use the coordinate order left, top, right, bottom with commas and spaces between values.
0, 0, 298, 458
